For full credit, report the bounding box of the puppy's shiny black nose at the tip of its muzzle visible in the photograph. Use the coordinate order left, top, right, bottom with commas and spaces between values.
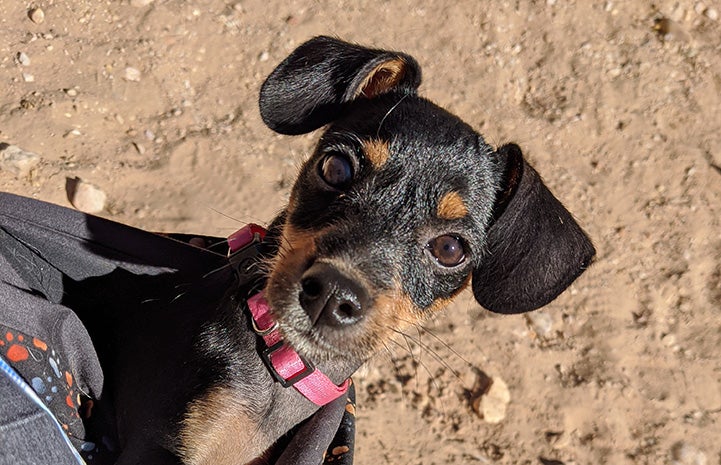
299, 263, 368, 326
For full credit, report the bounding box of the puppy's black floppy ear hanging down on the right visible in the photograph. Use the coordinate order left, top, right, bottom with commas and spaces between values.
472, 144, 596, 313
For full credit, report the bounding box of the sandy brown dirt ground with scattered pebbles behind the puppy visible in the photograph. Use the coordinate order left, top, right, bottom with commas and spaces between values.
0, 0, 721, 465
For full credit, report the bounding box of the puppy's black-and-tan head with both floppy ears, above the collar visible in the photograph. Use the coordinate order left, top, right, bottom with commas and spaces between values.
260, 37, 595, 365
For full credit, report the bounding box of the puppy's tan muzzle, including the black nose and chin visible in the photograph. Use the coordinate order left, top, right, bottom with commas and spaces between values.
265, 224, 434, 366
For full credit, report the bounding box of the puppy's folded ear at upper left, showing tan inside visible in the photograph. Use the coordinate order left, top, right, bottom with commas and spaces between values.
260, 36, 421, 135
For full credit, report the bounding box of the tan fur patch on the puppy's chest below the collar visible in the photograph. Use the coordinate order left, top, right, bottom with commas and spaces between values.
178, 387, 270, 465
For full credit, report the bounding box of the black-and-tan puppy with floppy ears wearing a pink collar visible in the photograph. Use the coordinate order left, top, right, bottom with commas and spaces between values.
0, 36, 595, 465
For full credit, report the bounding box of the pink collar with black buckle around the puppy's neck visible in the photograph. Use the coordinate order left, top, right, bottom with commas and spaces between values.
228, 223, 350, 406
